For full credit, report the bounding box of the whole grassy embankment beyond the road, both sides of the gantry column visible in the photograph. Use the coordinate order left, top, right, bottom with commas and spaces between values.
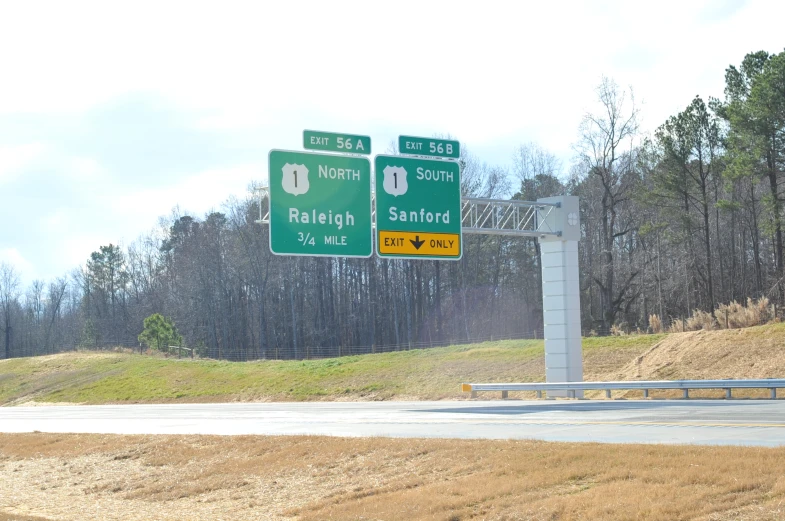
0, 324, 785, 405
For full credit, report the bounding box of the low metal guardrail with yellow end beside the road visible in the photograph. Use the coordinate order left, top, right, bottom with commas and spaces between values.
461, 378, 785, 400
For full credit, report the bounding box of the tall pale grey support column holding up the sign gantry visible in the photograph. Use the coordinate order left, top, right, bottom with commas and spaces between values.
538, 196, 583, 398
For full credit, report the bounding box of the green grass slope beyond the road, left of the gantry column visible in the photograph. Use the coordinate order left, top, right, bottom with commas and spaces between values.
0, 340, 543, 405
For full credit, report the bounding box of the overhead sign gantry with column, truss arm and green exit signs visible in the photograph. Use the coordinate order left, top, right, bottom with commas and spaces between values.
258, 130, 583, 397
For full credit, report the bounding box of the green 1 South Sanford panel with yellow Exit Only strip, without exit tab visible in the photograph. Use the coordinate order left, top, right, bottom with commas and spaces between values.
375, 156, 463, 260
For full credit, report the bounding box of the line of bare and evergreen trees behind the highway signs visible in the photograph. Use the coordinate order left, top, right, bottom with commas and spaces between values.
0, 51, 785, 360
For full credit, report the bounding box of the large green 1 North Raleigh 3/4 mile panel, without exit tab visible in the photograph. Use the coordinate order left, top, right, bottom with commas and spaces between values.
269, 150, 373, 257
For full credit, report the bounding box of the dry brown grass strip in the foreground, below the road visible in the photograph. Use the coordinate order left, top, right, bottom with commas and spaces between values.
0, 434, 785, 521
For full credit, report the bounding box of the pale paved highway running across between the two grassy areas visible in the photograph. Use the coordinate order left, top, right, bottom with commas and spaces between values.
0, 400, 785, 446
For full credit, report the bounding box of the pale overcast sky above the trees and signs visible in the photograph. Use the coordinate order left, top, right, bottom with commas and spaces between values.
0, 0, 785, 284
